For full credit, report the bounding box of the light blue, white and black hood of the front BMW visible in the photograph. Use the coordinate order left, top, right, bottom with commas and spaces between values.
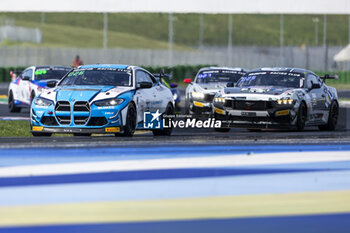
41, 86, 132, 102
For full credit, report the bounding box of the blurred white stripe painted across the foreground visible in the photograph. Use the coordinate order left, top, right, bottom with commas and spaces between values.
0, 151, 350, 177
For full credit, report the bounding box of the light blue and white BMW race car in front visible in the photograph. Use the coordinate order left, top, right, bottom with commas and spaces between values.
31, 65, 174, 136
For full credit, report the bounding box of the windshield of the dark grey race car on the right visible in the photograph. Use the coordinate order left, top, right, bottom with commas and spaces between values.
236, 72, 305, 88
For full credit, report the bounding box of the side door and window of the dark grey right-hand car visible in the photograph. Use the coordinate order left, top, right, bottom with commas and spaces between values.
307, 74, 326, 121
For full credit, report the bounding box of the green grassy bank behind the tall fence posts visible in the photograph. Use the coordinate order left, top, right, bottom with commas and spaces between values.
0, 13, 348, 48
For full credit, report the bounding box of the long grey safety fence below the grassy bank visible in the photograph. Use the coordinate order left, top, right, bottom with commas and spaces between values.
0, 46, 350, 71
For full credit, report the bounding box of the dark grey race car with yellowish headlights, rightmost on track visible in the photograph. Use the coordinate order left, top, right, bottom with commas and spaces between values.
214, 68, 339, 131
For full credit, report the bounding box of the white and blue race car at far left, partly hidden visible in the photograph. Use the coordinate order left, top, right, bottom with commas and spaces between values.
8, 66, 72, 112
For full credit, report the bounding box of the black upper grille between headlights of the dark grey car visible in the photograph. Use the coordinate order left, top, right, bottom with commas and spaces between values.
225, 100, 272, 111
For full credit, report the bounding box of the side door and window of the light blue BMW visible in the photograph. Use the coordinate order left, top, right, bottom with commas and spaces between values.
135, 70, 154, 123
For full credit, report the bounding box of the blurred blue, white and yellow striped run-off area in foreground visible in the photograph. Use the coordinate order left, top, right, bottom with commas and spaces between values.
0, 142, 350, 232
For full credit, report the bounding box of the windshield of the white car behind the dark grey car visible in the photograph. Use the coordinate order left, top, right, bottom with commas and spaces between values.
196, 70, 244, 83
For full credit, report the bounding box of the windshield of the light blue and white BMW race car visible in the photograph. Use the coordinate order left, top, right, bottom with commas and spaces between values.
59, 69, 132, 86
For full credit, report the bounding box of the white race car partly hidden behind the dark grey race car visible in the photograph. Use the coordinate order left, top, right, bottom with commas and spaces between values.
184, 67, 246, 115
